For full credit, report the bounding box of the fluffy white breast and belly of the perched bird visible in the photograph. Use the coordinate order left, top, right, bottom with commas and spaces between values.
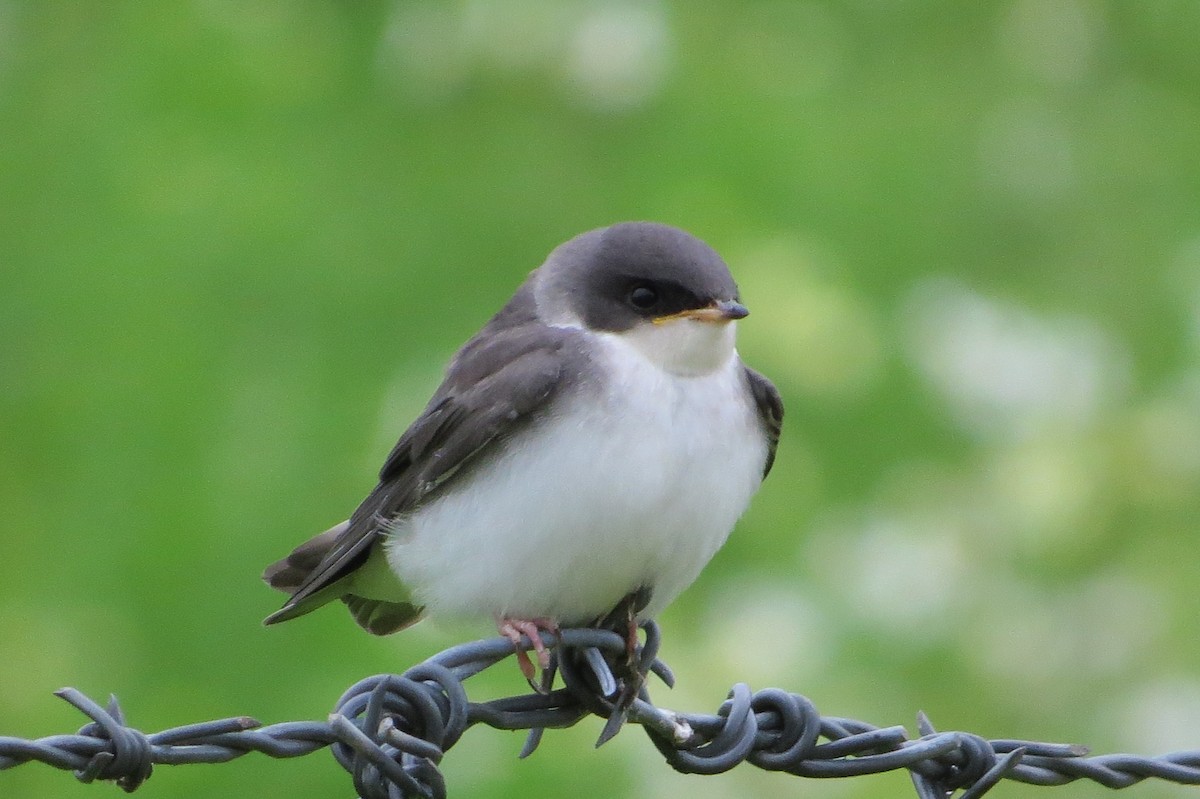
386, 336, 767, 624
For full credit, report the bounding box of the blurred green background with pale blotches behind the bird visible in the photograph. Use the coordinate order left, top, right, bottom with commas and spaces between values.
0, 0, 1200, 799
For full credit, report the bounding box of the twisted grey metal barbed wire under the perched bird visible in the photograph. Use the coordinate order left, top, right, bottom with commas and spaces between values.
0, 623, 1200, 799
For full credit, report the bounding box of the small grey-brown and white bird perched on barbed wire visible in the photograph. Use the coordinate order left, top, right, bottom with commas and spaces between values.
263, 222, 784, 683
